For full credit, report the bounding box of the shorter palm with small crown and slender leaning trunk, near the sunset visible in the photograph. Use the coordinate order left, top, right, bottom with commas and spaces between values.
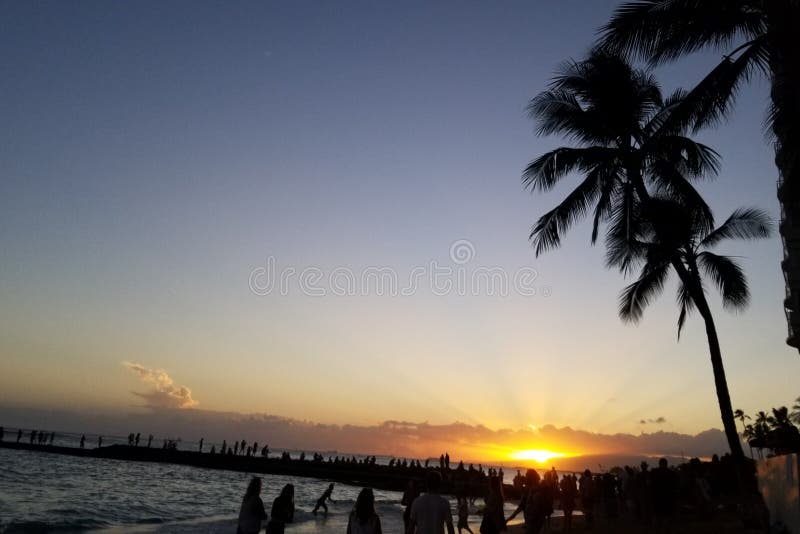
619, 198, 771, 456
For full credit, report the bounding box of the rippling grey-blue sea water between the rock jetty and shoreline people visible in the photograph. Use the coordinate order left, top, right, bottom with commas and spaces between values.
0, 449, 511, 534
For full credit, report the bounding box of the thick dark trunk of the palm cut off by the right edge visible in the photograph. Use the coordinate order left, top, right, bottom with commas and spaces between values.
764, 2, 800, 349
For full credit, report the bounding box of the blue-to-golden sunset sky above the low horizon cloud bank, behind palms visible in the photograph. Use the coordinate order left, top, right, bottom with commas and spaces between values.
0, 0, 800, 460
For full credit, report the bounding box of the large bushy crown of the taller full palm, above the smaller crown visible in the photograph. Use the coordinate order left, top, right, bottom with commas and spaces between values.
523, 51, 719, 264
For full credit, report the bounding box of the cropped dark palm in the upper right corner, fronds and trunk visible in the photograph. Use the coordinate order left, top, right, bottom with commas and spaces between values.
600, 0, 800, 348
